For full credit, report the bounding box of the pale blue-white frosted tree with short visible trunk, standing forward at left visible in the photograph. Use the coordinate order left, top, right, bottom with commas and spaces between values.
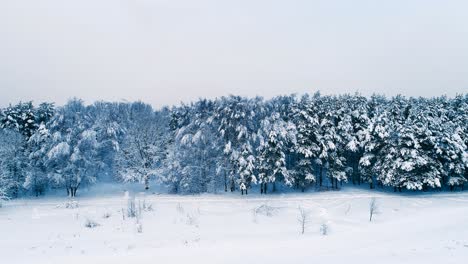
44, 99, 101, 197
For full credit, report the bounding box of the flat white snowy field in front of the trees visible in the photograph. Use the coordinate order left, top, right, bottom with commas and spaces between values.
0, 187, 468, 264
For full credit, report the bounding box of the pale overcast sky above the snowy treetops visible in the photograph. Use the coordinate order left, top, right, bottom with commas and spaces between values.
0, 0, 468, 106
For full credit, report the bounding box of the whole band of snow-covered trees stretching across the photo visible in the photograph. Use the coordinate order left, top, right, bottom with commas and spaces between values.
0, 93, 468, 197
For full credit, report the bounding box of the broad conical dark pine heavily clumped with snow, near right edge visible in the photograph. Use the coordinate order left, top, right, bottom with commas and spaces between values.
376, 101, 441, 191
